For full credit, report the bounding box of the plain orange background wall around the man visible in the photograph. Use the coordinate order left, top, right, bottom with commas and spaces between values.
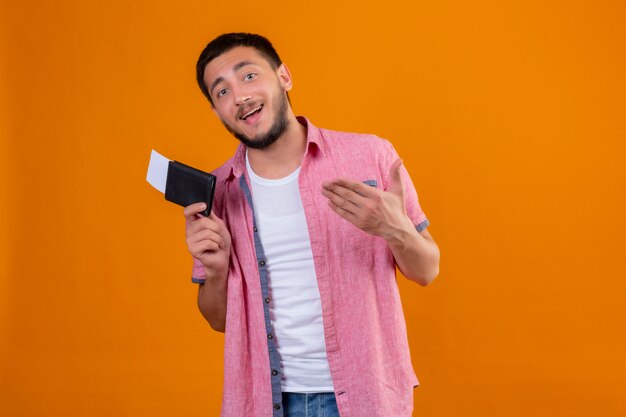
0, 0, 626, 417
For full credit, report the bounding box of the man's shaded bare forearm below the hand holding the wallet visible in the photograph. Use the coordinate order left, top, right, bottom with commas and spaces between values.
198, 270, 228, 333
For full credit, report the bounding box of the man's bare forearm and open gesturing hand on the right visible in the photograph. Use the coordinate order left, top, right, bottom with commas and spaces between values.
322, 159, 439, 285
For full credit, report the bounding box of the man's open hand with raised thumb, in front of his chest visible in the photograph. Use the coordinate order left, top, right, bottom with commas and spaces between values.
322, 159, 414, 241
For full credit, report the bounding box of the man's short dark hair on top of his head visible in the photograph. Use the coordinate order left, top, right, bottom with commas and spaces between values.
196, 32, 283, 106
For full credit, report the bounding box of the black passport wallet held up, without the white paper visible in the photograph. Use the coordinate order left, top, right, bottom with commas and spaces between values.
165, 161, 216, 216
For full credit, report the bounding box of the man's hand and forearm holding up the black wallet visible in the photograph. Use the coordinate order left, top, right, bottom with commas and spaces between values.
184, 203, 231, 332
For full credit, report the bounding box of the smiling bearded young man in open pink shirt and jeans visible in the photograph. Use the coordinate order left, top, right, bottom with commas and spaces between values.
184, 33, 439, 417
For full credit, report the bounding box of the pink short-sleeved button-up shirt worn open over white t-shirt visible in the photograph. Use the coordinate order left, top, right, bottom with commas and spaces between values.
192, 117, 428, 417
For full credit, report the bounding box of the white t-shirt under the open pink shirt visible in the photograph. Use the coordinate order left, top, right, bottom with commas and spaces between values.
246, 153, 333, 392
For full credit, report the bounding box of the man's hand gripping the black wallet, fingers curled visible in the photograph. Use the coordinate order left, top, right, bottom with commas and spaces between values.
184, 203, 231, 278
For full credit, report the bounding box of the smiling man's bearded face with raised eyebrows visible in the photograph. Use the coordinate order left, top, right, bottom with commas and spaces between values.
204, 46, 291, 149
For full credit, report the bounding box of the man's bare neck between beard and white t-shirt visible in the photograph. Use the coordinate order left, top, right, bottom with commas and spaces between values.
248, 109, 306, 179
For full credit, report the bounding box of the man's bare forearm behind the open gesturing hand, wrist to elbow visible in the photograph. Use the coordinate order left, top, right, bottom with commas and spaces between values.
387, 224, 439, 285
